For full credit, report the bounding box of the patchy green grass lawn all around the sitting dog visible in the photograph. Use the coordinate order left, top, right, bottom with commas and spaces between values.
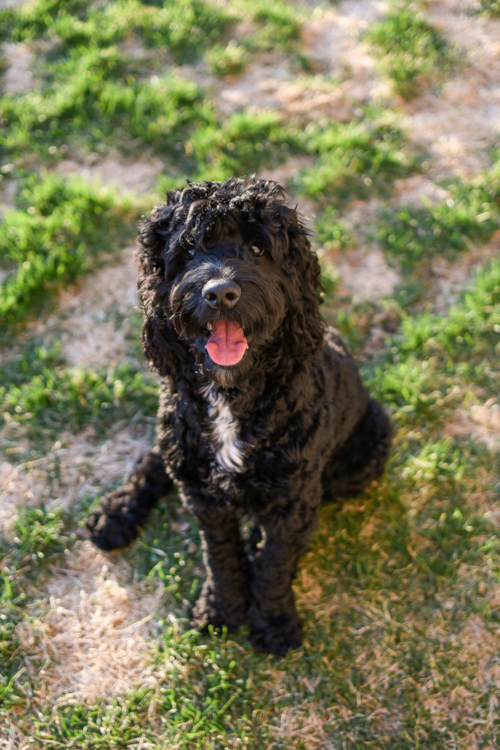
0, 0, 500, 750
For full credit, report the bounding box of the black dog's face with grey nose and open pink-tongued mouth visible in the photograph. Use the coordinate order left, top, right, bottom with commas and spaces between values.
170, 222, 289, 386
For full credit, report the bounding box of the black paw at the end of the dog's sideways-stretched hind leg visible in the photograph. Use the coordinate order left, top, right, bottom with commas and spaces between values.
86, 489, 140, 552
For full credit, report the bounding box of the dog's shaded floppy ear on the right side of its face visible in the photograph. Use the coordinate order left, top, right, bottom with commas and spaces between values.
283, 217, 325, 361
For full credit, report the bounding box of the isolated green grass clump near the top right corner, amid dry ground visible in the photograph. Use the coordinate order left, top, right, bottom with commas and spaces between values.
365, 7, 453, 99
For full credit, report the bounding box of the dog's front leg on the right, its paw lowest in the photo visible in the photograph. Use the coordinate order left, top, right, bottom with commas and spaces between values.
248, 502, 319, 656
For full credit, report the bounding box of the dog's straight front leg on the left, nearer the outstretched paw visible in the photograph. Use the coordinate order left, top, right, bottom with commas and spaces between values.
189, 500, 250, 631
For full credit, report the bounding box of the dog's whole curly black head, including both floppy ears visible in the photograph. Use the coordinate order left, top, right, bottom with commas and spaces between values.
139, 177, 323, 387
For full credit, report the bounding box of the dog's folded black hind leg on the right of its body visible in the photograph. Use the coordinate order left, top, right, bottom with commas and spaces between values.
322, 399, 393, 502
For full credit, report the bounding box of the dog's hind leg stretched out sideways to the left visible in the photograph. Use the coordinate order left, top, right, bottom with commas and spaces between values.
86, 448, 172, 552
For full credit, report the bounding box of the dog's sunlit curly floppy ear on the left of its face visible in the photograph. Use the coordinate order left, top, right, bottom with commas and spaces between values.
138, 190, 192, 376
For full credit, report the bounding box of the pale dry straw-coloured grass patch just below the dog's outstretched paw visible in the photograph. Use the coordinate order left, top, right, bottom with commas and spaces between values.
18, 542, 166, 703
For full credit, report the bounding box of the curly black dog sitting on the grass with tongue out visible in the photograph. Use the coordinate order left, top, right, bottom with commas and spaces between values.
88, 177, 391, 654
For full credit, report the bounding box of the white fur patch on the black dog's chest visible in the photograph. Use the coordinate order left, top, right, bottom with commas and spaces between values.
206, 388, 245, 471
